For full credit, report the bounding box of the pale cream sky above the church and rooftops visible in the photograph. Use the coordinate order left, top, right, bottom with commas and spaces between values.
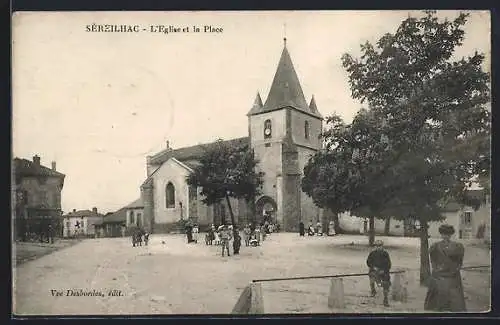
12, 11, 490, 213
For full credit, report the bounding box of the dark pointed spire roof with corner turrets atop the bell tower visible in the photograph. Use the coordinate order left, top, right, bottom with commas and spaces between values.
249, 40, 321, 118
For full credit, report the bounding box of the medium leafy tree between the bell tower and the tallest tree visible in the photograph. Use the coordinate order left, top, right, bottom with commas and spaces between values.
302, 109, 398, 245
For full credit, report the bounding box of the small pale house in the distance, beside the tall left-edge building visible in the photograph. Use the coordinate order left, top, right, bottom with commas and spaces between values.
63, 208, 104, 237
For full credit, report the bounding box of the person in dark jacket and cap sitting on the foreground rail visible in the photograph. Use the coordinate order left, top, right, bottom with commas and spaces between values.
366, 240, 391, 307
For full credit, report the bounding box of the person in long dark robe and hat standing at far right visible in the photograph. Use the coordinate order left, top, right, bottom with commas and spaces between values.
424, 225, 466, 312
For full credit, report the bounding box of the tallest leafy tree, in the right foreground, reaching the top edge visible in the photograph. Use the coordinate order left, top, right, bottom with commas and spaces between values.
342, 11, 490, 283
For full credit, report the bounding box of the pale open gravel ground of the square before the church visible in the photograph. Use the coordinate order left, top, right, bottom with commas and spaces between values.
13, 233, 490, 316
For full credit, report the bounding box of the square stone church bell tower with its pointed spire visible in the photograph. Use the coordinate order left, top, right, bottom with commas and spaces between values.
247, 38, 323, 231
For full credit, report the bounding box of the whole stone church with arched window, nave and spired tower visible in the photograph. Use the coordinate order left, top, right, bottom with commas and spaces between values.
140, 39, 323, 233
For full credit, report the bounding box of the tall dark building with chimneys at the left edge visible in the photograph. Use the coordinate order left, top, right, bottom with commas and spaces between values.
12, 155, 65, 239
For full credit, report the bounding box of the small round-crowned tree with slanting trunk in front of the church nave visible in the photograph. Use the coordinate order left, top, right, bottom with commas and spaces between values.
186, 140, 263, 234
